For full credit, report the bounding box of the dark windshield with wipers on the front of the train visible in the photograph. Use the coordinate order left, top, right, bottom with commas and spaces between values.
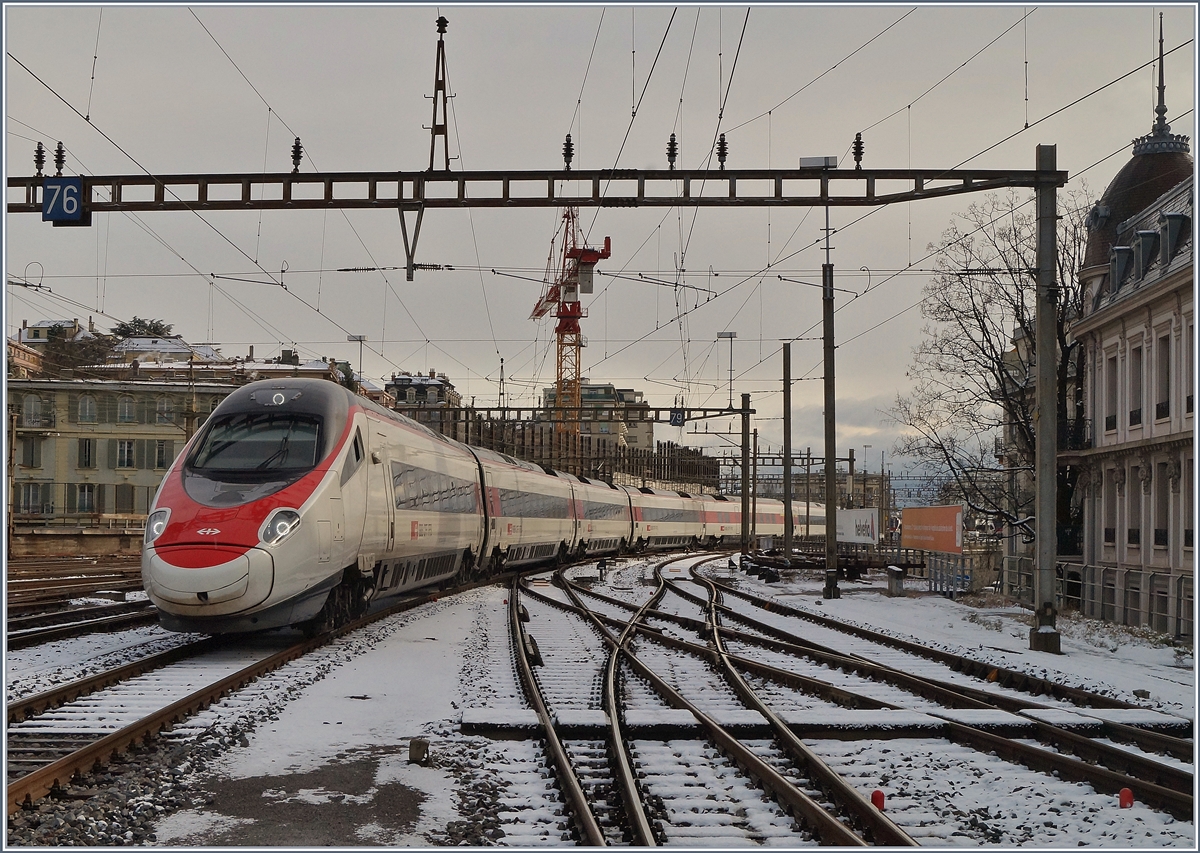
187, 412, 322, 480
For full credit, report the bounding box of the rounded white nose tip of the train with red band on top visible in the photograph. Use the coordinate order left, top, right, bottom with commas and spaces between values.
142, 546, 275, 617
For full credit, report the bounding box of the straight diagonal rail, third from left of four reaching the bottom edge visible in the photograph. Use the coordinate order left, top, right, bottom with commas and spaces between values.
549, 558, 866, 847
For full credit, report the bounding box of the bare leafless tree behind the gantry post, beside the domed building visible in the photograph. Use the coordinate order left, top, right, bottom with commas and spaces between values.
886, 185, 1091, 547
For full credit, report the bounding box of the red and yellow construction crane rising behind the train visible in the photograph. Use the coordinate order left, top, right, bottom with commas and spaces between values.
529, 208, 612, 434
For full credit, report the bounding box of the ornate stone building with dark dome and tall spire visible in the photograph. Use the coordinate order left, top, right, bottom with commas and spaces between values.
1060, 24, 1195, 639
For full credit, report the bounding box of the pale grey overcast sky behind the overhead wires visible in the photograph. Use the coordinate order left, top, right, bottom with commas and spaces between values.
5, 4, 1196, 470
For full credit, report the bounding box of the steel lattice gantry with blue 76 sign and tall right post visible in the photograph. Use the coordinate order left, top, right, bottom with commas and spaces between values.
7, 154, 1068, 651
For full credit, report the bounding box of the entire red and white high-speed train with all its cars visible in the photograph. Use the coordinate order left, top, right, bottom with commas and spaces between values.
142, 378, 824, 633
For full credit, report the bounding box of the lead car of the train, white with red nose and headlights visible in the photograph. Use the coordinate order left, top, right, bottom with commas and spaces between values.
142, 378, 486, 633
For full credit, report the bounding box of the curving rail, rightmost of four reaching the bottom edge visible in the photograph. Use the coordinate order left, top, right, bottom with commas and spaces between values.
686, 571, 919, 847
